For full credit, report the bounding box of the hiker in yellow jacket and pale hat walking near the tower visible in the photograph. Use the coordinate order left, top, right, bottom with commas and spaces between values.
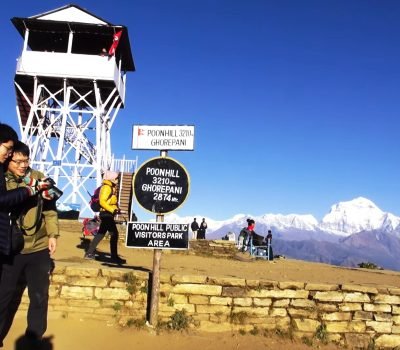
84, 170, 126, 264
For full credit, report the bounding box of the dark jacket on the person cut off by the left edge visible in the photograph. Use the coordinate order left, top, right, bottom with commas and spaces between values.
0, 164, 29, 255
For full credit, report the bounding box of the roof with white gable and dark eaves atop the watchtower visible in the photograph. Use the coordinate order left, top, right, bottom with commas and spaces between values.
11, 4, 135, 71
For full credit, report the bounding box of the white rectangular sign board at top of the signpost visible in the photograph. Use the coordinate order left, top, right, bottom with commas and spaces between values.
132, 125, 194, 151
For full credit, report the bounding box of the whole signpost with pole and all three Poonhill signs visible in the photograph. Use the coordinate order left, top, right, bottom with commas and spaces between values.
130, 125, 194, 327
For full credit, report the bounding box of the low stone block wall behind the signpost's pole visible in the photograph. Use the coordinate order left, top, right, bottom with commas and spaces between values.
14, 266, 400, 348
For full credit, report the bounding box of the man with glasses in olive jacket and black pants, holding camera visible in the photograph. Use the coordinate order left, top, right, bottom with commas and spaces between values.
0, 141, 59, 344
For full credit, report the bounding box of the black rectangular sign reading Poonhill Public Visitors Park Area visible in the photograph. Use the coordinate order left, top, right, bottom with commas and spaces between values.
125, 222, 189, 249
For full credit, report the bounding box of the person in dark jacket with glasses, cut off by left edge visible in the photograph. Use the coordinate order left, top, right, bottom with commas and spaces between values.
0, 123, 43, 260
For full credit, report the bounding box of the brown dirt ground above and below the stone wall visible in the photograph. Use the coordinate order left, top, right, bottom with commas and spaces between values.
4, 222, 400, 350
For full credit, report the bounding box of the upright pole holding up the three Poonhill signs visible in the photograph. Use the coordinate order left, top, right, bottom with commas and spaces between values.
150, 151, 167, 327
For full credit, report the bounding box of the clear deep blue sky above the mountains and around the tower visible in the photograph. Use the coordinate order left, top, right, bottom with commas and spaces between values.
0, 0, 400, 220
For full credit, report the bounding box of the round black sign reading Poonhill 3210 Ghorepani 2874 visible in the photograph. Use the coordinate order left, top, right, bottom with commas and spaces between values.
133, 157, 189, 214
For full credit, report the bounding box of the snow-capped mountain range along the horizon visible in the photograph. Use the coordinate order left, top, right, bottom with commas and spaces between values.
165, 197, 400, 270
